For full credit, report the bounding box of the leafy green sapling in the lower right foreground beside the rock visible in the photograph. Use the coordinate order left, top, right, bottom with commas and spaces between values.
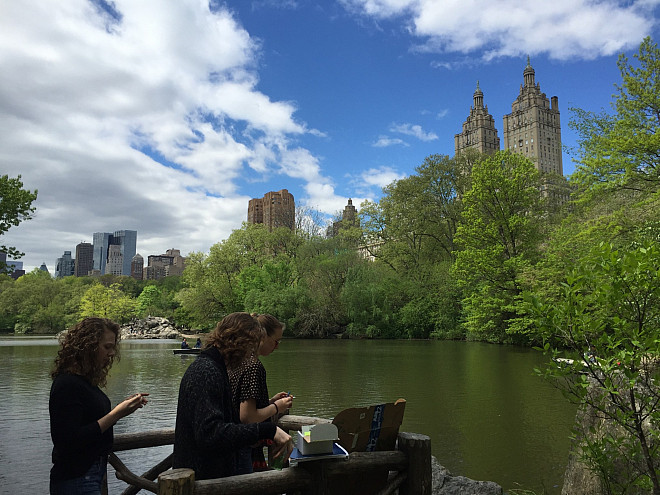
527, 243, 660, 495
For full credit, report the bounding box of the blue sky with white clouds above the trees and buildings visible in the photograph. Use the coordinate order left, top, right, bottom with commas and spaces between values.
0, 0, 660, 273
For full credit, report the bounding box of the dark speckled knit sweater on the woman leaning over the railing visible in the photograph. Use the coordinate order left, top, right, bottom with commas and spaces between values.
172, 347, 276, 480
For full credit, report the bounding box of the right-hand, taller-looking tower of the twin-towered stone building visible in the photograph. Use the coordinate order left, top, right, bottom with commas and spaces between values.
506, 57, 564, 175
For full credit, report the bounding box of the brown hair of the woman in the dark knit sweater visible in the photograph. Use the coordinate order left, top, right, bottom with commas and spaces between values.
204, 313, 265, 368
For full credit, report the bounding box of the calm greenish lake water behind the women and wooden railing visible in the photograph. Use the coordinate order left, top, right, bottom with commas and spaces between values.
0, 338, 575, 495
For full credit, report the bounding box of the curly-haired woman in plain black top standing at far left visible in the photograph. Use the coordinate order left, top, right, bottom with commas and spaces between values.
48, 318, 149, 495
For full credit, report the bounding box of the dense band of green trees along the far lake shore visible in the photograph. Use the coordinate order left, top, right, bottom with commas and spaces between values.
0, 39, 660, 352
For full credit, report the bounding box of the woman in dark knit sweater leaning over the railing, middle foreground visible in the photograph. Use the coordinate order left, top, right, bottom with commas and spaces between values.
172, 313, 291, 480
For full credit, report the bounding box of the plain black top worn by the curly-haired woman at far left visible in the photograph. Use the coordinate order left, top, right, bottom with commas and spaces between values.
48, 373, 112, 481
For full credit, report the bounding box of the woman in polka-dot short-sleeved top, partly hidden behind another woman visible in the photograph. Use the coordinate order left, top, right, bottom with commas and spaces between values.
229, 314, 293, 474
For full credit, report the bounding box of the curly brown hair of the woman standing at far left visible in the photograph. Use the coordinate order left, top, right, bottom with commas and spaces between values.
50, 318, 119, 387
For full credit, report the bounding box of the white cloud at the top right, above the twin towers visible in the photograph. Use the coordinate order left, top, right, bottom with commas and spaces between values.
343, 0, 659, 60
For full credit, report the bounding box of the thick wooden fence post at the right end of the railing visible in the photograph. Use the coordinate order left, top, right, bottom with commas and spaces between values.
398, 432, 431, 495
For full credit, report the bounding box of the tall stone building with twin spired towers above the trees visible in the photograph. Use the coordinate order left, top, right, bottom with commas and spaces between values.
454, 57, 563, 175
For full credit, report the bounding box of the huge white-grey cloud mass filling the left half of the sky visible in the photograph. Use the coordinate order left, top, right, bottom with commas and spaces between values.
0, 0, 334, 269
